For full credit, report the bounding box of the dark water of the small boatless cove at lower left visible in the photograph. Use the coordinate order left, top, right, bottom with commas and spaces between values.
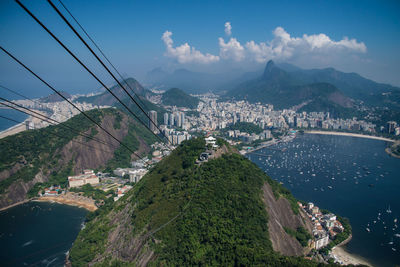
0, 202, 87, 266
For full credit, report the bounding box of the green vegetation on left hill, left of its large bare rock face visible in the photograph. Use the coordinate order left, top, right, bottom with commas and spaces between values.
0, 110, 103, 194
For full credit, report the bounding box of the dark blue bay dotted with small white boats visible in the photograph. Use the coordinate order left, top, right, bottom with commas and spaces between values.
249, 134, 400, 266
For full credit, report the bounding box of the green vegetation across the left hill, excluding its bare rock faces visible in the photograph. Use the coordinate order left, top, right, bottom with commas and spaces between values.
0, 109, 156, 203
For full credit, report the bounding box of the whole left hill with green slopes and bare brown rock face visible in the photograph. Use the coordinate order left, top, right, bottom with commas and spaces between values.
0, 109, 155, 207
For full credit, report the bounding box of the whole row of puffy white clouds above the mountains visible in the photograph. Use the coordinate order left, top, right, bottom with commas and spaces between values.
161, 26, 367, 64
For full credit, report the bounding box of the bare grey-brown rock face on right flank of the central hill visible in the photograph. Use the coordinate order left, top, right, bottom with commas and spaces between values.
262, 183, 312, 256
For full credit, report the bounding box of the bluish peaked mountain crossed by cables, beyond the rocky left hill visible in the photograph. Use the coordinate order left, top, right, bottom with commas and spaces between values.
76, 78, 151, 106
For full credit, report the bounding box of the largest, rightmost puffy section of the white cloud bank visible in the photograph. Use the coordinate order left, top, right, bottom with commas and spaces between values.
246, 27, 367, 62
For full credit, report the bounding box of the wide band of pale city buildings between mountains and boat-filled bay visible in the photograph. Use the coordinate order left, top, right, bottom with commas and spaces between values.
183, 94, 376, 136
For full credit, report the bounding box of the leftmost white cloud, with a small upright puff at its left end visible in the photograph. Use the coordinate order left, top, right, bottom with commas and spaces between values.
161, 31, 219, 64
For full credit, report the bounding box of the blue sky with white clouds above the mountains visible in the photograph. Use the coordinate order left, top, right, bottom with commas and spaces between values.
0, 0, 400, 97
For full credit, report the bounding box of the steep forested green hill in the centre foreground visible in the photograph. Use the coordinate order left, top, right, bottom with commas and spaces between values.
69, 138, 340, 266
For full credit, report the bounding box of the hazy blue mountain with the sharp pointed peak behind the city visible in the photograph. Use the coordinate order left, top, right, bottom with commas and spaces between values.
227, 61, 353, 116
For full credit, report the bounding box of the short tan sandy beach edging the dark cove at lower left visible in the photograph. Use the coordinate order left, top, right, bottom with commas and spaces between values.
35, 192, 97, 211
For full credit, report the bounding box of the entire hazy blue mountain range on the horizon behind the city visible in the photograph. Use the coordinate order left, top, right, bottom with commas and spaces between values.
146, 61, 400, 114
